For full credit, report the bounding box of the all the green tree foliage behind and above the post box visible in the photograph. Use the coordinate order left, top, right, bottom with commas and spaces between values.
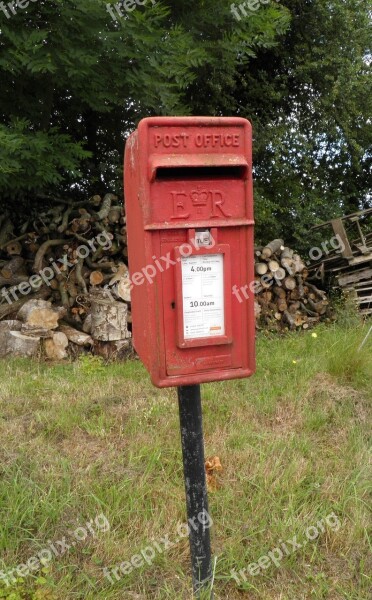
0, 0, 372, 244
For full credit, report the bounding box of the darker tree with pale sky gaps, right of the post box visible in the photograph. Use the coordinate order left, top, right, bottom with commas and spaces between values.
232, 0, 372, 247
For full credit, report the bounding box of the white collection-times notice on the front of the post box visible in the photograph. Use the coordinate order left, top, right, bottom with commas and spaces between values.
181, 254, 225, 340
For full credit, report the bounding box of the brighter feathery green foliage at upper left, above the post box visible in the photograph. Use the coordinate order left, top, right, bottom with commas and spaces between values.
0, 0, 288, 198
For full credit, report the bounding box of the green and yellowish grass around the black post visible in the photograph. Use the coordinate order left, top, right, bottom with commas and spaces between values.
0, 321, 372, 600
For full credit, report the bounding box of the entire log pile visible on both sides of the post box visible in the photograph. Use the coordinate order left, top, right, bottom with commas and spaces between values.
0, 194, 329, 360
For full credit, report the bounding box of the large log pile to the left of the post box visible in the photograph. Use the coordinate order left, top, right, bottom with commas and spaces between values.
0, 194, 131, 360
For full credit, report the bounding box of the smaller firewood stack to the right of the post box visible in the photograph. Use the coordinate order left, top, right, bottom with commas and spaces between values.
255, 239, 331, 330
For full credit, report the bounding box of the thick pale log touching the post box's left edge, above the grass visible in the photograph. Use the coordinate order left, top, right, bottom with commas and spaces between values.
91, 298, 130, 342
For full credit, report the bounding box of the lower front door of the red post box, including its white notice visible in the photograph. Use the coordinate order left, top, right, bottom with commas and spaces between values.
159, 228, 246, 376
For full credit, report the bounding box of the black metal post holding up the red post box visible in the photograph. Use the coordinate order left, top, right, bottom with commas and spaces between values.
178, 385, 213, 598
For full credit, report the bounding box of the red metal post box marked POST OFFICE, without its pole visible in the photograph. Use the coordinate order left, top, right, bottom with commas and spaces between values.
124, 117, 255, 387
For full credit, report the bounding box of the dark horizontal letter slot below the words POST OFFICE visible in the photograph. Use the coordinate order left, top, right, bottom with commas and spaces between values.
156, 166, 247, 181
